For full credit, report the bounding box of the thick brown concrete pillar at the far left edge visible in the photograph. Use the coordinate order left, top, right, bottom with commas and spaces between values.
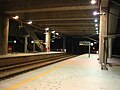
0, 16, 9, 55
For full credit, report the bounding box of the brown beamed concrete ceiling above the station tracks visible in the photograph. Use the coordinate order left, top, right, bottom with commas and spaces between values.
0, 0, 99, 36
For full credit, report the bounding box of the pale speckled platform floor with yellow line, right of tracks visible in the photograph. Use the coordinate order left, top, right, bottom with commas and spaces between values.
0, 54, 120, 90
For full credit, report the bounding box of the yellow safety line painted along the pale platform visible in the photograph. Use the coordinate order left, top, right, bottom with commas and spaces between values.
4, 61, 73, 90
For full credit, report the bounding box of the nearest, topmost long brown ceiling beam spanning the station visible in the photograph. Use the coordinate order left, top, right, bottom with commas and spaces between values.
5, 5, 98, 14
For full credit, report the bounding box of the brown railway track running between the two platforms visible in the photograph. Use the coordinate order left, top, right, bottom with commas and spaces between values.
0, 54, 76, 80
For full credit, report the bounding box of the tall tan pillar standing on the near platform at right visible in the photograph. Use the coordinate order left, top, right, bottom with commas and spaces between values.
99, 9, 108, 65
